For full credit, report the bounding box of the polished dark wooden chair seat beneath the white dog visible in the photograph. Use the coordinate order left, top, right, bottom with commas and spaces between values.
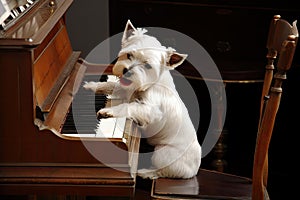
151, 169, 252, 200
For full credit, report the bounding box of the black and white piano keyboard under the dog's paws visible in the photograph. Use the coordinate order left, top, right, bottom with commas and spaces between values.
61, 75, 126, 138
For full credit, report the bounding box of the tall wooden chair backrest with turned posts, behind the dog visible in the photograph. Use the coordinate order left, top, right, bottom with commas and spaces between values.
252, 15, 298, 199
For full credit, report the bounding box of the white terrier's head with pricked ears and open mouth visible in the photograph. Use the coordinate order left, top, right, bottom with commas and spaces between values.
113, 20, 187, 91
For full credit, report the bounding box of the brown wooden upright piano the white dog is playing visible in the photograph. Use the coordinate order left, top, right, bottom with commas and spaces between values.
0, 0, 140, 199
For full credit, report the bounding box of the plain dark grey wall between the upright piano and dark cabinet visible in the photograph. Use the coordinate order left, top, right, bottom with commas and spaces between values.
66, 0, 109, 57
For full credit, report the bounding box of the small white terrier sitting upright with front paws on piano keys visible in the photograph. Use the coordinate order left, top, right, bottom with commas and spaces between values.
84, 20, 201, 179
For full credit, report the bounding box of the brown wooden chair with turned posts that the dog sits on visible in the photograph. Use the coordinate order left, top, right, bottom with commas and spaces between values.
151, 15, 298, 200
